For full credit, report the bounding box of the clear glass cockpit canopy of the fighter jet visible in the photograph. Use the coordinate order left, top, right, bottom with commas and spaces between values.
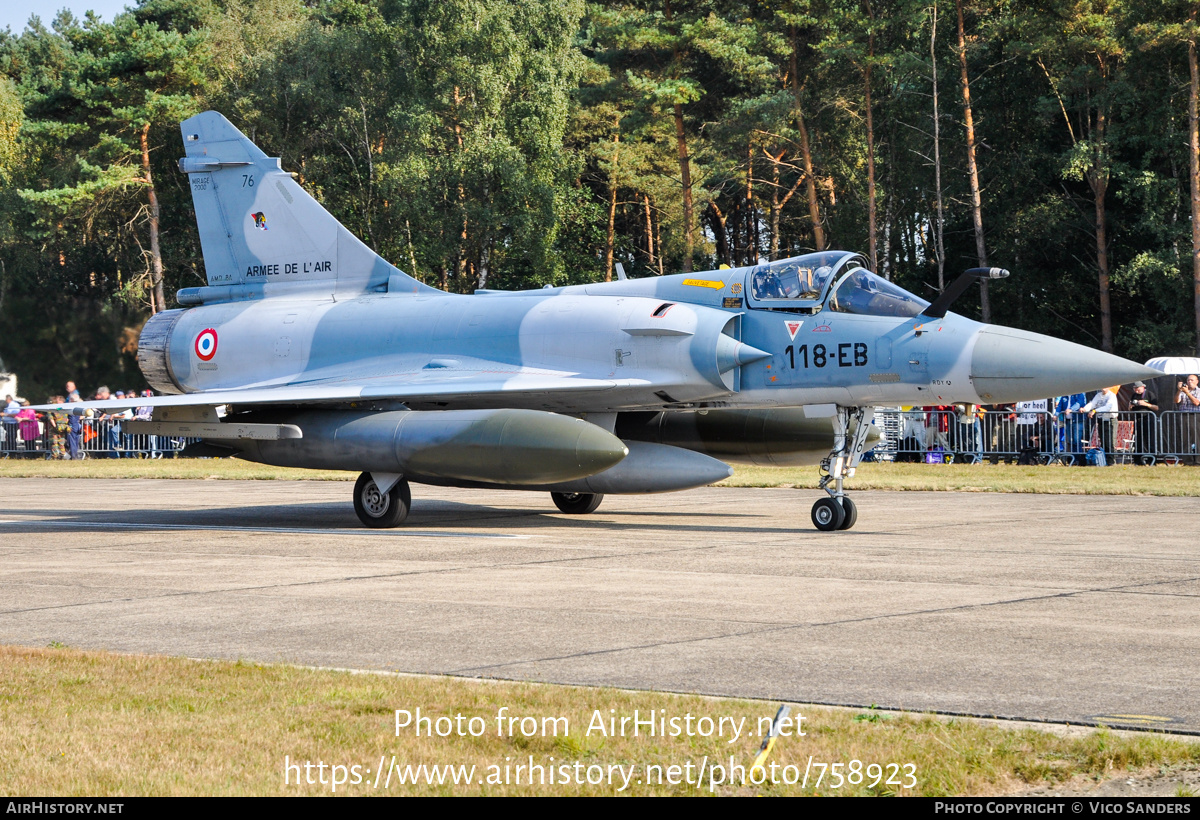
749, 251, 929, 317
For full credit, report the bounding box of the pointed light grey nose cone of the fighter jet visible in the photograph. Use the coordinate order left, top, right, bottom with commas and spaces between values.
971, 325, 1162, 403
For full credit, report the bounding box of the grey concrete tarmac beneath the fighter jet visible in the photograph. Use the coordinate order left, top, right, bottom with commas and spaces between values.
0, 479, 1200, 734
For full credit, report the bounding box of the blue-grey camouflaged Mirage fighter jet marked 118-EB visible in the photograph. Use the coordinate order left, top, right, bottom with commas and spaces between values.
42, 112, 1158, 531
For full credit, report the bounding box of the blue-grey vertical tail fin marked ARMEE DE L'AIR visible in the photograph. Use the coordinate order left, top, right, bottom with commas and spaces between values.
179, 112, 433, 301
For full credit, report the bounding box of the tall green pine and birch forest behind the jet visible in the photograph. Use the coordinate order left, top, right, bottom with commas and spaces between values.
0, 0, 1200, 400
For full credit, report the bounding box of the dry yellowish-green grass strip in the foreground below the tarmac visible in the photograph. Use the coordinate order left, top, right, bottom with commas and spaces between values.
0, 647, 1200, 796
